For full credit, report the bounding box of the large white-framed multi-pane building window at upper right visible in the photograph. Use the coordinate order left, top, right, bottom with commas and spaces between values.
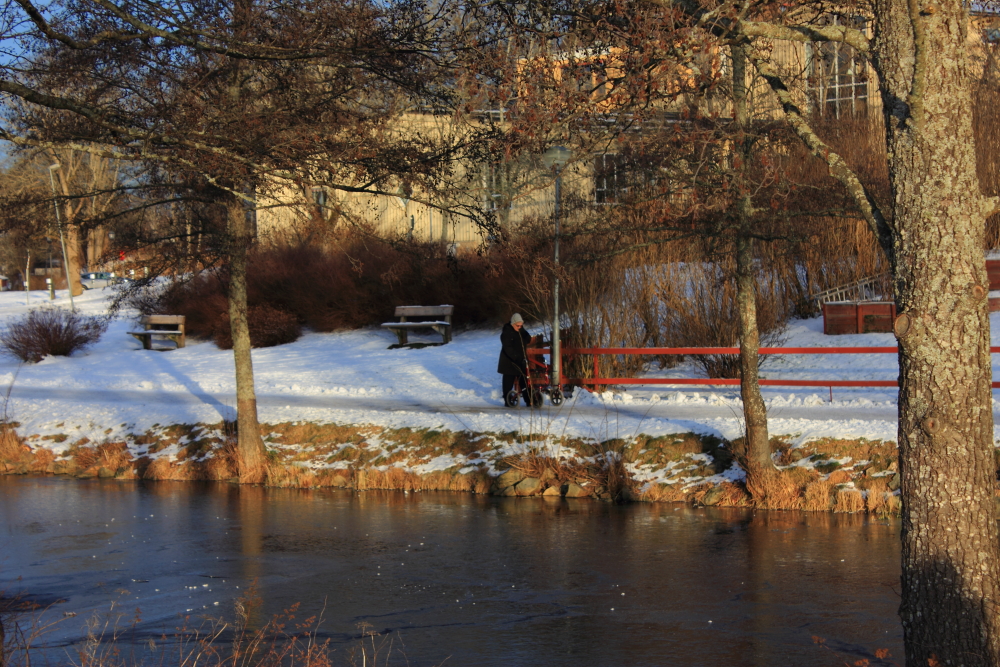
806, 15, 868, 118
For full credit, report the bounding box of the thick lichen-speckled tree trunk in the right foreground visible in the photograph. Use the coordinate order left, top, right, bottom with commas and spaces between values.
875, 0, 1000, 667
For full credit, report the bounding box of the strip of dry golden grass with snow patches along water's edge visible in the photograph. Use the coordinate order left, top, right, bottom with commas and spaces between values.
0, 422, 916, 515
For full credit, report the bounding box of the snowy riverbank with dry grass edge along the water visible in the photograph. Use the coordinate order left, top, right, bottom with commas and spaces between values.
0, 290, 980, 513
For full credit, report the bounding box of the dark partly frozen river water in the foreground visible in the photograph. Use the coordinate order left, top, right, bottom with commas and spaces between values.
0, 476, 902, 667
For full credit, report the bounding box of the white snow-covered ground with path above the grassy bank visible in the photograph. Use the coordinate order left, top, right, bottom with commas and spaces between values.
0, 290, 1000, 451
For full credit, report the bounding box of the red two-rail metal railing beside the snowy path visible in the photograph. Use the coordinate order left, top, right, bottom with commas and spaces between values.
528, 347, 1000, 400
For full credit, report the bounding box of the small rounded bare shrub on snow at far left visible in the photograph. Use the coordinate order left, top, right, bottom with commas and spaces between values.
0, 308, 108, 363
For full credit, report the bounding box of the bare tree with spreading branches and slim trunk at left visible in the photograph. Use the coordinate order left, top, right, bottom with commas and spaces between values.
0, 0, 484, 482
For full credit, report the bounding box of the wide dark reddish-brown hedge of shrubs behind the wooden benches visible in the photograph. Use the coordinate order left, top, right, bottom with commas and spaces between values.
150, 234, 518, 348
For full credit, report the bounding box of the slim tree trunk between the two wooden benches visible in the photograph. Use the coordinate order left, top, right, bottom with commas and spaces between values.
226, 190, 267, 484
